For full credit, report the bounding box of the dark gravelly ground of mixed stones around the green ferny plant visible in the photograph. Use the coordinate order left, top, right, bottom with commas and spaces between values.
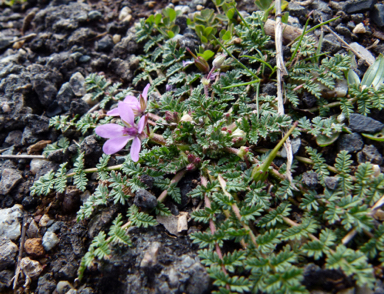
0, 0, 384, 294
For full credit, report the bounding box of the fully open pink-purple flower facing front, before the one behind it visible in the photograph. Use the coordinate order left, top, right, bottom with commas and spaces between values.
95, 102, 147, 162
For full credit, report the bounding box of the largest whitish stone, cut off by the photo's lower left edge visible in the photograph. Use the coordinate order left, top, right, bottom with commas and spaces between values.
0, 204, 23, 240
